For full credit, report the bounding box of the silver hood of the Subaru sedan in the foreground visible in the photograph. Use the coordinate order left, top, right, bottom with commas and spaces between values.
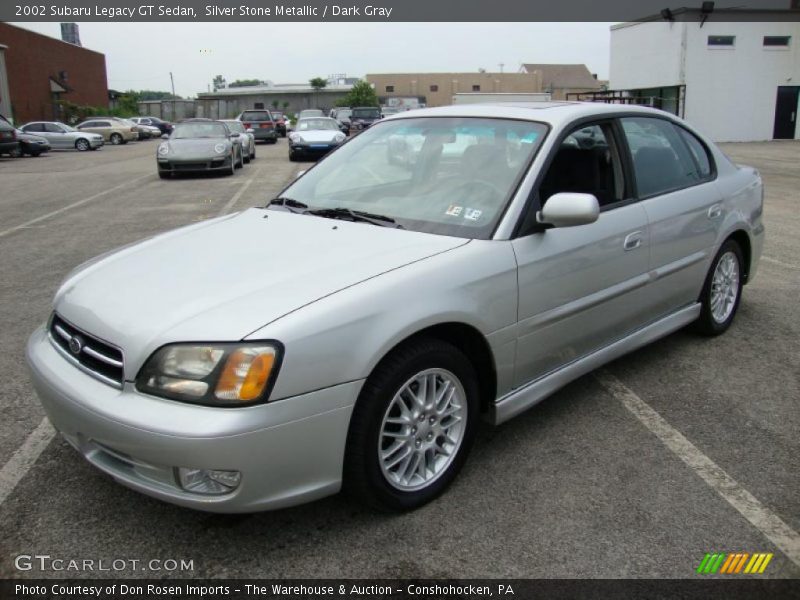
54, 208, 468, 379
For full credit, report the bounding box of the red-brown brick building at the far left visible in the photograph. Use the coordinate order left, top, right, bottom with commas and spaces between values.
0, 22, 108, 123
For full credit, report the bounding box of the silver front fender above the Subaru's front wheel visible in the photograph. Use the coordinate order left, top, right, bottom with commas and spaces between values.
248, 240, 517, 399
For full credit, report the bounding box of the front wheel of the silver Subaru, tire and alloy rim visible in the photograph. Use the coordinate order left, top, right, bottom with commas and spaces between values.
344, 339, 478, 510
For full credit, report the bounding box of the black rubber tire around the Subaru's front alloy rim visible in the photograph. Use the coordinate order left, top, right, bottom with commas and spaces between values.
343, 338, 479, 511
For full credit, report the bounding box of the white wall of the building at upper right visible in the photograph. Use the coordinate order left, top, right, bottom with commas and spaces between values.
610, 20, 800, 142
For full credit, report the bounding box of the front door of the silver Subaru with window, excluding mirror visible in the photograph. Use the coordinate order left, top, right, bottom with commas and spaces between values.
512, 121, 650, 386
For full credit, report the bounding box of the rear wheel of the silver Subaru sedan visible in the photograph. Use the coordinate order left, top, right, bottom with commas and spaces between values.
695, 240, 744, 336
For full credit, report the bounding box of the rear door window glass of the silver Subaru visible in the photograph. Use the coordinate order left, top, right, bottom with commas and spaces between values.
621, 117, 703, 197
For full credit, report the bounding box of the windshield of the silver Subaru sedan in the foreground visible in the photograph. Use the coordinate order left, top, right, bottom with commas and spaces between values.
281, 118, 546, 239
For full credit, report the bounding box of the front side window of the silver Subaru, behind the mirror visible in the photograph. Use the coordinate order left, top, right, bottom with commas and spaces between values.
539, 123, 625, 207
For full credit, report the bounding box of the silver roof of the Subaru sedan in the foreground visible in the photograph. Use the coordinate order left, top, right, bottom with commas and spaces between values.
385, 102, 673, 126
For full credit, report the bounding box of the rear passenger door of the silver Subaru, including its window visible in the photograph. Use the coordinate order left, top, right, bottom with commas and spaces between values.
621, 117, 725, 316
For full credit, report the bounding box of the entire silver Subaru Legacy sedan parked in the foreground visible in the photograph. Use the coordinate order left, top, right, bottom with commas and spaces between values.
27, 103, 764, 512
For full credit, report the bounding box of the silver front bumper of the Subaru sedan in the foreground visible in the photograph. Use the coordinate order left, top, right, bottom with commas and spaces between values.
27, 327, 363, 513
